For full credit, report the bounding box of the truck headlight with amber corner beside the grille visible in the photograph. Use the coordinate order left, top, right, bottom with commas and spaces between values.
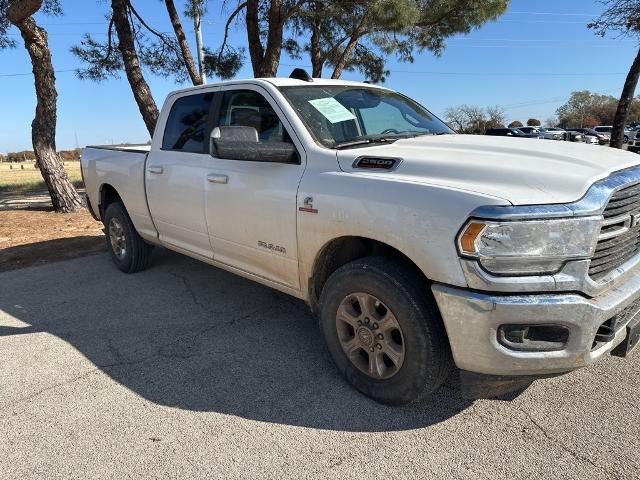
458, 216, 602, 275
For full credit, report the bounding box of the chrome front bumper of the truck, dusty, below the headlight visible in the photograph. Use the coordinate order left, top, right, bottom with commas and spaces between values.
432, 271, 640, 376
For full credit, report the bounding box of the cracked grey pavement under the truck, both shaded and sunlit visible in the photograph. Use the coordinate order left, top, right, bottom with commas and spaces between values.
0, 251, 640, 479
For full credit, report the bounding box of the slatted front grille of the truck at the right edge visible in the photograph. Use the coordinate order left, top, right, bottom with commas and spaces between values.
589, 183, 640, 280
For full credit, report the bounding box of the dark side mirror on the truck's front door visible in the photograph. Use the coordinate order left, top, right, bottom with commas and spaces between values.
210, 126, 300, 163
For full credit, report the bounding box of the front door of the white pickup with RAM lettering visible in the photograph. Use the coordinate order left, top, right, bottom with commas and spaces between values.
205, 86, 306, 288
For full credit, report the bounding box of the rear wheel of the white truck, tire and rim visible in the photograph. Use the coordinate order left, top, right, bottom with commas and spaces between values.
104, 202, 153, 273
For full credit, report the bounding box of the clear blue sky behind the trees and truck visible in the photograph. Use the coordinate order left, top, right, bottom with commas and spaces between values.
0, 0, 637, 153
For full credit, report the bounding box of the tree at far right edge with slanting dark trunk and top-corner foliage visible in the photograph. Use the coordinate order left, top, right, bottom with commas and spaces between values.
588, 0, 640, 148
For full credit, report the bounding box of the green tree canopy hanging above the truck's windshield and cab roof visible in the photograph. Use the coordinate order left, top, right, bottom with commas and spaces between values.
286, 0, 508, 82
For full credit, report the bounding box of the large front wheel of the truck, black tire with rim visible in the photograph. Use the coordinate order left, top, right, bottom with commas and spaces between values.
320, 257, 453, 405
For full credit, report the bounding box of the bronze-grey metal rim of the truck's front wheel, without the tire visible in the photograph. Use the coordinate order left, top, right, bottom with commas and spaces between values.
336, 293, 405, 380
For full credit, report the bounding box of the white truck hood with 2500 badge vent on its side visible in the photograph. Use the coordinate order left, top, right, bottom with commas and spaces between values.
338, 135, 640, 205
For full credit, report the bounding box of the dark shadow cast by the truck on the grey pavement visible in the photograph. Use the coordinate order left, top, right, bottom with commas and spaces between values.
0, 249, 482, 432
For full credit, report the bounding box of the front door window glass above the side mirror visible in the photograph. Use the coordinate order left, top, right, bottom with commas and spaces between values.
218, 90, 291, 143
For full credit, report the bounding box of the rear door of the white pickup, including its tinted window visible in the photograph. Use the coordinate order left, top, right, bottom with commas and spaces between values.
145, 89, 215, 258
